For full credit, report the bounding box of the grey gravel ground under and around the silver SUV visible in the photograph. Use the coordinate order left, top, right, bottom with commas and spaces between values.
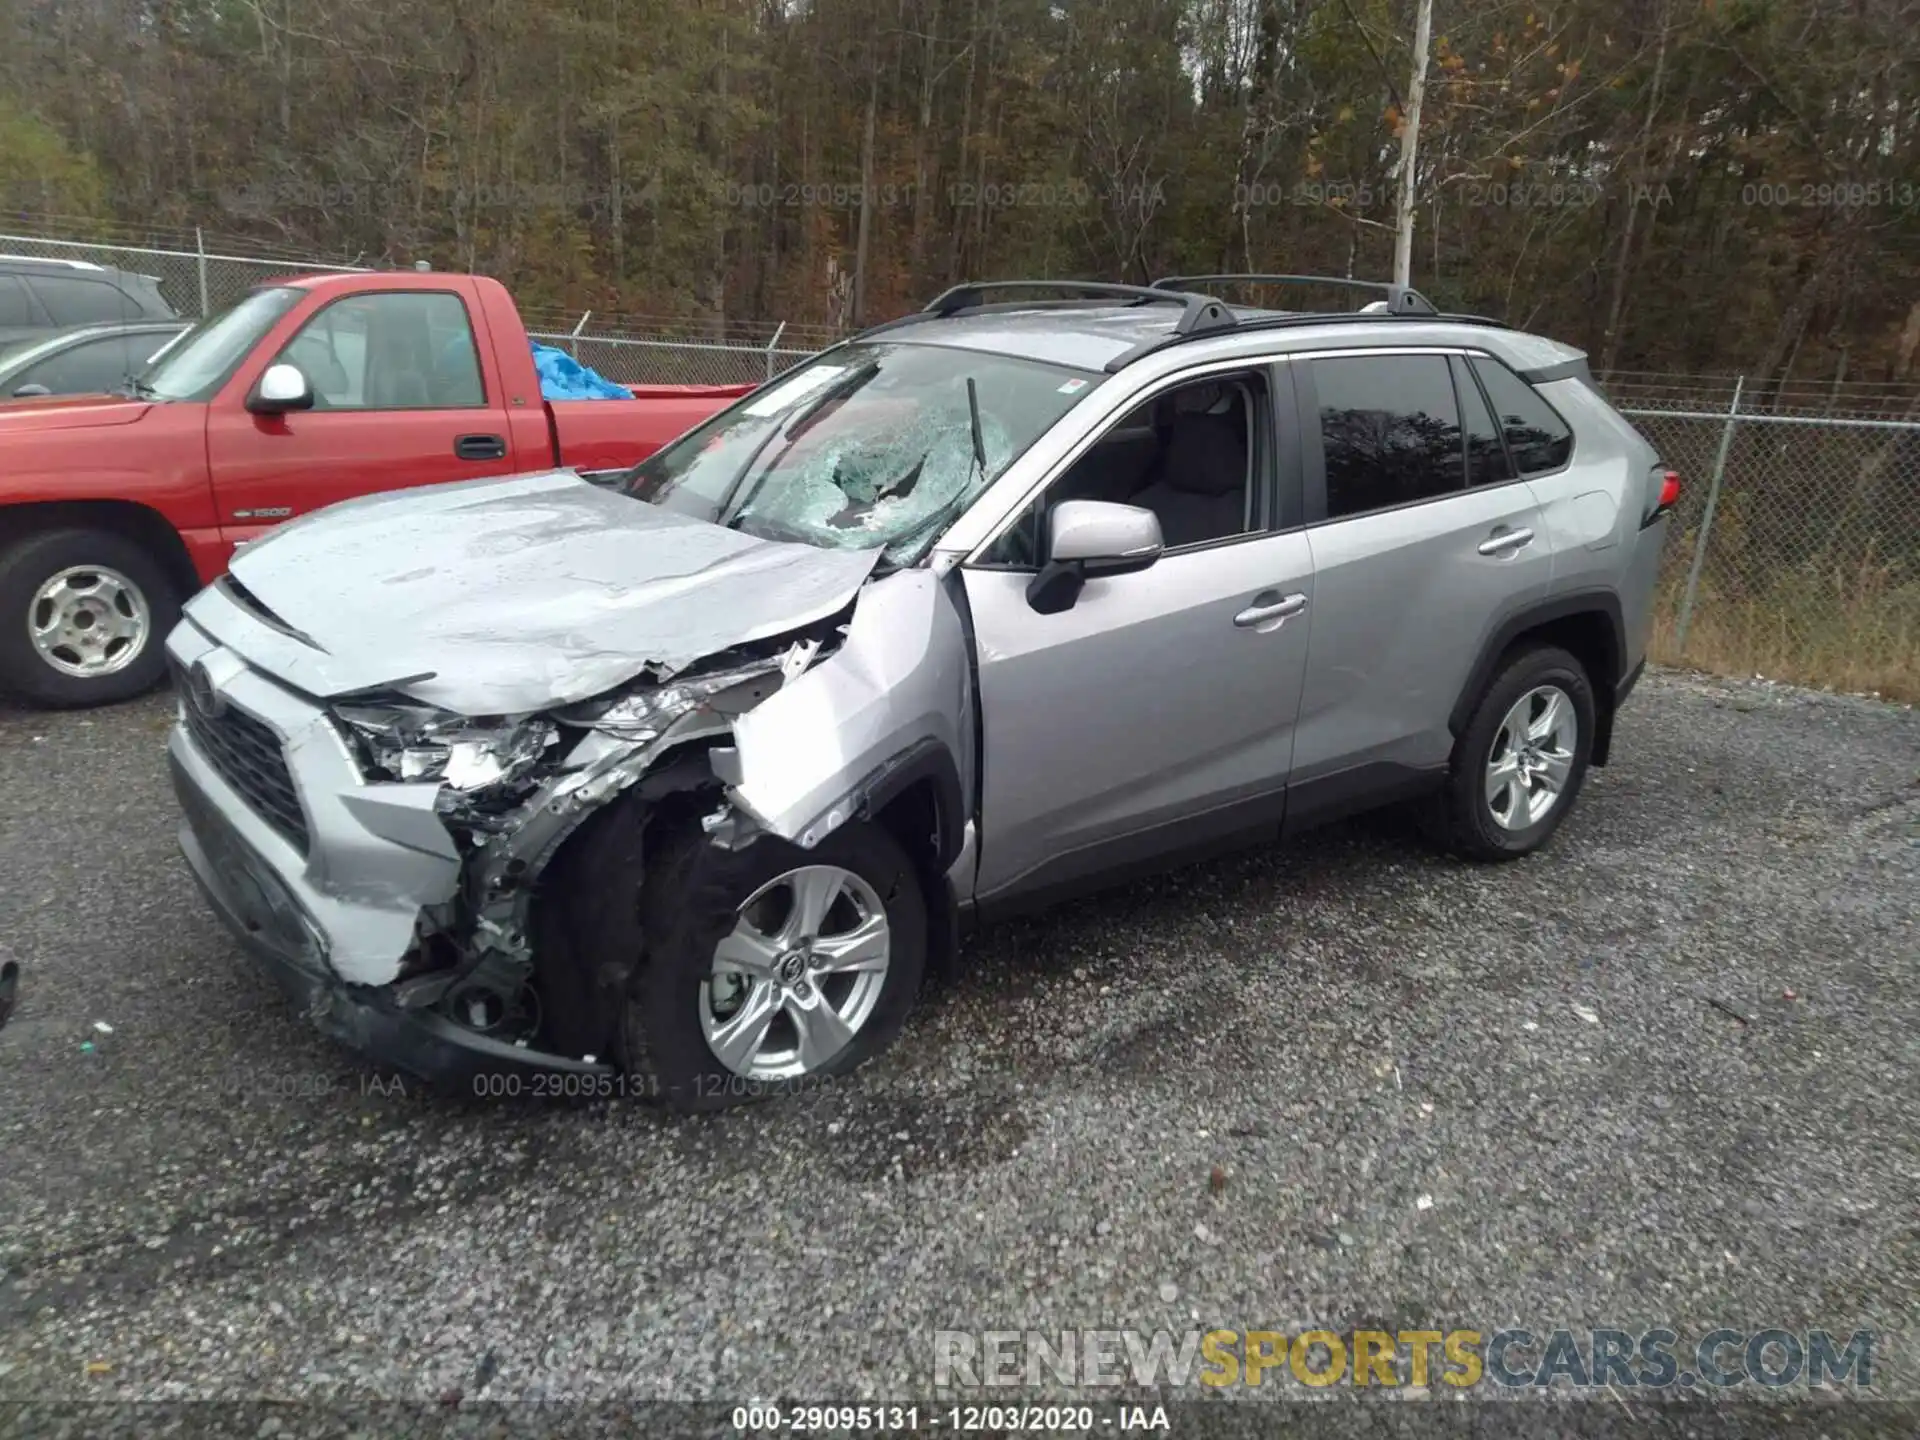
0, 674, 1920, 1432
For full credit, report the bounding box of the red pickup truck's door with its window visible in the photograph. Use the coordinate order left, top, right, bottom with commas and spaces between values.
207, 290, 515, 543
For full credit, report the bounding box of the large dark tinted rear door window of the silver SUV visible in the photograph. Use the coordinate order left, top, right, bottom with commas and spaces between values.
1313, 355, 1467, 520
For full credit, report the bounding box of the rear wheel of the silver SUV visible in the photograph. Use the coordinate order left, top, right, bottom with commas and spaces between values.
1436, 645, 1594, 860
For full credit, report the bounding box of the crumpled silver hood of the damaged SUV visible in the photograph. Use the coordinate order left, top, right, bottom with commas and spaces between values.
206, 470, 879, 714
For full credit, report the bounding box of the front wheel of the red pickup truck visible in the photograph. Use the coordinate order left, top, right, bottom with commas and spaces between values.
0, 530, 180, 708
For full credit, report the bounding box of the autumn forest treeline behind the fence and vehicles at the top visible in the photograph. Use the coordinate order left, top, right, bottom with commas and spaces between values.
0, 0, 1920, 386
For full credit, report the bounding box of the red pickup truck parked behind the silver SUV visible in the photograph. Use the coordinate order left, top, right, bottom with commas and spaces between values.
0, 271, 753, 705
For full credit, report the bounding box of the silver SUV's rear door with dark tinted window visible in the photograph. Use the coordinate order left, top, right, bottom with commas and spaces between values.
1288, 349, 1553, 806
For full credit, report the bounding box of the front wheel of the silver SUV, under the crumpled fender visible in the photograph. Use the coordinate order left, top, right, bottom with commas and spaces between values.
622, 822, 927, 1112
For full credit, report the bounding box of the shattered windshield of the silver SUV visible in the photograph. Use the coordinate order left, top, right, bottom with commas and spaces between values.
626, 342, 1100, 564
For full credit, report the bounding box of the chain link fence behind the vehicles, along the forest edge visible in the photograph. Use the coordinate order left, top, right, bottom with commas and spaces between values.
0, 223, 1920, 701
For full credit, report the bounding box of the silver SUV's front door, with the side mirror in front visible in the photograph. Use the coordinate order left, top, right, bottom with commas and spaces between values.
964, 365, 1313, 904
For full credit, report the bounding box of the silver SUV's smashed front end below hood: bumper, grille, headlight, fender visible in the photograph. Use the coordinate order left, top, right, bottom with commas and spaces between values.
169, 545, 973, 1079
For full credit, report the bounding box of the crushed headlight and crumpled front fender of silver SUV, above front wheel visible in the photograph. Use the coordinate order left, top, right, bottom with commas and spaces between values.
347, 570, 973, 1064
